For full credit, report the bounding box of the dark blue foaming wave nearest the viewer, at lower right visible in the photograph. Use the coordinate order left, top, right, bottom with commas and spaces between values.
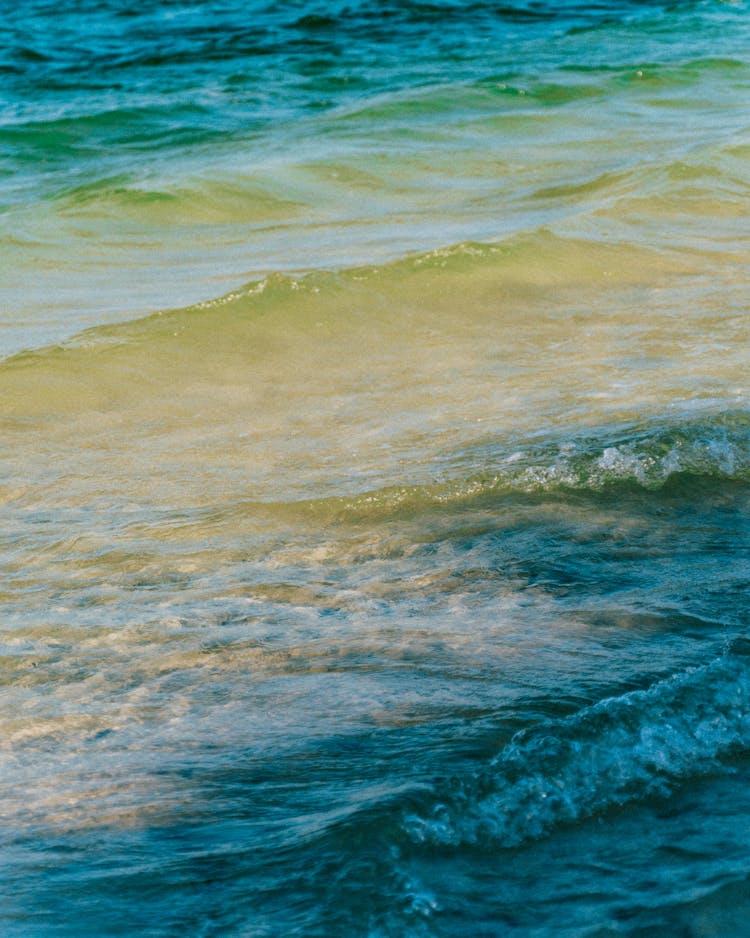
403, 637, 750, 848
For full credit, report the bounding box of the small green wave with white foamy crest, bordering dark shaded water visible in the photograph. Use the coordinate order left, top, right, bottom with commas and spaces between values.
290, 410, 750, 521
